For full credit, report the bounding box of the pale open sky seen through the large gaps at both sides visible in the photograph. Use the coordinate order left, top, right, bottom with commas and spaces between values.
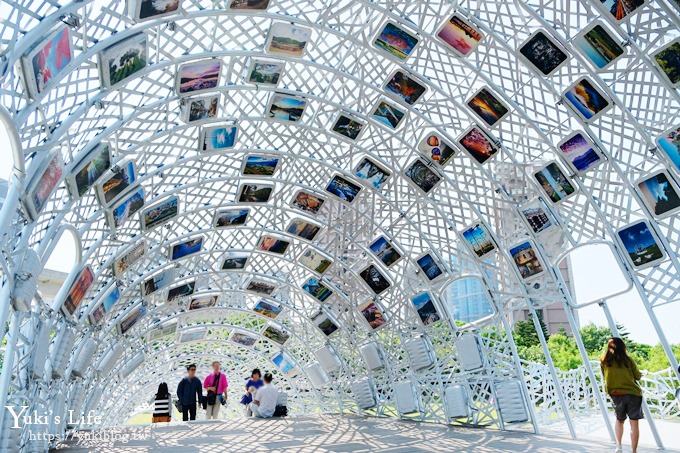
0, 126, 680, 344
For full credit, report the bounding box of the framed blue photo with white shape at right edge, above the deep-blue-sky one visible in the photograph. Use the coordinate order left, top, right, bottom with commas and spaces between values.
635, 170, 680, 219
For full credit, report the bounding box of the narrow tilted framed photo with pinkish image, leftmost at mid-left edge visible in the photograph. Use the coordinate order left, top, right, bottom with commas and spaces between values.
22, 151, 64, 220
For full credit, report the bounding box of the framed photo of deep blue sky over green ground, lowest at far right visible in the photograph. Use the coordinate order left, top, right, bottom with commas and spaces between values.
616, 220, 666, 270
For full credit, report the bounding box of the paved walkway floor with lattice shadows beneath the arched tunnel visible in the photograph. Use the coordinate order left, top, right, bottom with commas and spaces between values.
58, 415, 676, 453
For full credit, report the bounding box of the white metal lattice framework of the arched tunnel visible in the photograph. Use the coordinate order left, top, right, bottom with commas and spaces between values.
0, 0, 680, 448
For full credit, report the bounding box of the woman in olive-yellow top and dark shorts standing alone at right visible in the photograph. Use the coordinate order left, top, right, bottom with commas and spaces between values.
600, 337, 643, 453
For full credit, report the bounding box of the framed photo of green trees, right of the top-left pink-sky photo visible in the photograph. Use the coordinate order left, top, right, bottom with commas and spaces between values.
98, 33, 149, 88
